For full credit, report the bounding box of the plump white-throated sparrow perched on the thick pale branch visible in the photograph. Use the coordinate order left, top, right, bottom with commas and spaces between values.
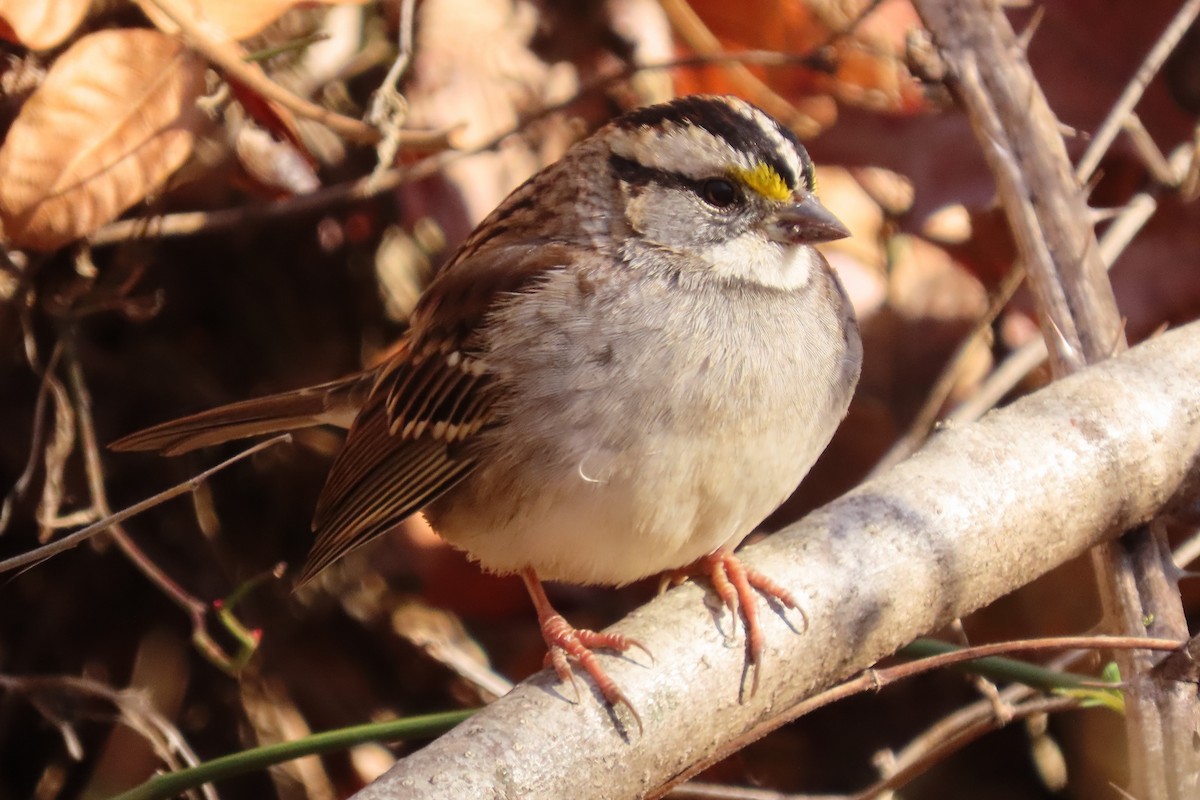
113, 96, 862, 724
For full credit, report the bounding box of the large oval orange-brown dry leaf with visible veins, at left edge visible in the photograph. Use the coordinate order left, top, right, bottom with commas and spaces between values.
0, 30, 205, 249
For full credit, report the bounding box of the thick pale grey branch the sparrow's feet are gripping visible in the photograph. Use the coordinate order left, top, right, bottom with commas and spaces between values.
356, 323, 1200, 800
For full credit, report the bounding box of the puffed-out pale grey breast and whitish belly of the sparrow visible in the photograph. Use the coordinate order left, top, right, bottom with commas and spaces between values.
417, 266, 859, 584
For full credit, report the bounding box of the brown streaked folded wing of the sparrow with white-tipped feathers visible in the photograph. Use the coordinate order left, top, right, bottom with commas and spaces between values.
299, 237, 571, 583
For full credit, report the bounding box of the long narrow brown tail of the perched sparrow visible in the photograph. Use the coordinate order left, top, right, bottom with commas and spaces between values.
109, 372, 374, 456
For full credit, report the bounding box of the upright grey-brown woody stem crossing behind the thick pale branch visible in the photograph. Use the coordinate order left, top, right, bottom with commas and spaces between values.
916, 0, 1200, 798
